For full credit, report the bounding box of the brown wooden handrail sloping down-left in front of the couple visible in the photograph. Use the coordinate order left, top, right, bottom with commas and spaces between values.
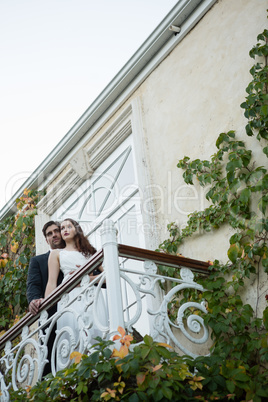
0, 250, 103, 350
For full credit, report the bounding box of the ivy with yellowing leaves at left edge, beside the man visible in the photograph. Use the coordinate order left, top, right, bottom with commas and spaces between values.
0, 189, 42, 335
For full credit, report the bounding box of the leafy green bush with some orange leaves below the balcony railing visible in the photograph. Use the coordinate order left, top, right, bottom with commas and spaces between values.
10, 328, 268, 402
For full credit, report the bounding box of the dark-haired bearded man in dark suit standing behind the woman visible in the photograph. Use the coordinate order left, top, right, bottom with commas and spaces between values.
27, 221, 64, 376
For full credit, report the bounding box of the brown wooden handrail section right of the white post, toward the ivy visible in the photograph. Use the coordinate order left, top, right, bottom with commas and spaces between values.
118, 244, 210, 274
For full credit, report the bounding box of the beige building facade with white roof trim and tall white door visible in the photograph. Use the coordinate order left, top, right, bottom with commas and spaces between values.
1, 0, 268, 318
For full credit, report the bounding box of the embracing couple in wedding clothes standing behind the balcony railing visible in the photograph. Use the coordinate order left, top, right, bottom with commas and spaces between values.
27, 218, 106, 375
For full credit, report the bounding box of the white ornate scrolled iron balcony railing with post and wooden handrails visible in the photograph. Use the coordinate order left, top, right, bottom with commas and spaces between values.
0, 220, 209, 402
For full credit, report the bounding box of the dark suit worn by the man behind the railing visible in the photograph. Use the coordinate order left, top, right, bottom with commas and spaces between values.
27, 251, 63, 376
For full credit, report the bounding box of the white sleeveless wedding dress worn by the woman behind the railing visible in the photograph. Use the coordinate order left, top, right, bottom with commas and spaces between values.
56, 249, 108, 371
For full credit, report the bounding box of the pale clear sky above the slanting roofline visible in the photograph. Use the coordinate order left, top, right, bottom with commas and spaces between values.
0, 0, 180, 210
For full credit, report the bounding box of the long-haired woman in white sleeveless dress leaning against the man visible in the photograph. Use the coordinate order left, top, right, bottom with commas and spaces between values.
45, 218, 107, 371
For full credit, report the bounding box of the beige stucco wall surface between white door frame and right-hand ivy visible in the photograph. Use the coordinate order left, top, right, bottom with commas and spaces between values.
130, 0, 268, 260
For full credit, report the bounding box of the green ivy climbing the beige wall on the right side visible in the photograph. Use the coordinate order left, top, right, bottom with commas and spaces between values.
157, 30, 268, 401
